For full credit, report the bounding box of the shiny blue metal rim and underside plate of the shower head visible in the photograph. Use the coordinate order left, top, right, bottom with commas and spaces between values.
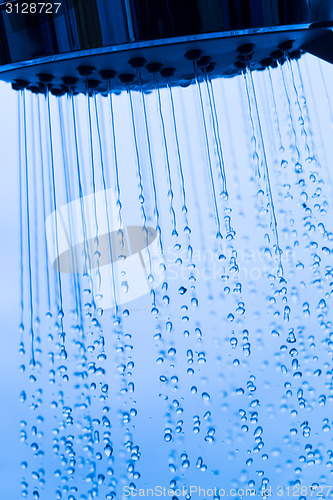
0, 25, 331, 94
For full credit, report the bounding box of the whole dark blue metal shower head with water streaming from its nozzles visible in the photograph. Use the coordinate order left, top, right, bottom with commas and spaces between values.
0, 0, 333, 95
